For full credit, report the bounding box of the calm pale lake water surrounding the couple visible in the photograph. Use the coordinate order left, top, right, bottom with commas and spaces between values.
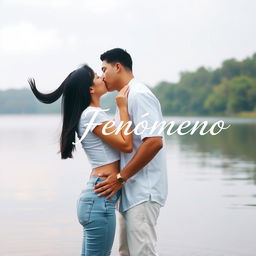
0, 115, 256, 256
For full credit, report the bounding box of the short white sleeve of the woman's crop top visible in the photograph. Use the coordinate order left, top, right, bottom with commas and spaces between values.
83, 109, 110, 132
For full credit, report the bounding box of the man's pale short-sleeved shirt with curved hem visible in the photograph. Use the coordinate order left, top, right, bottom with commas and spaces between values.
115, 78, 168, 212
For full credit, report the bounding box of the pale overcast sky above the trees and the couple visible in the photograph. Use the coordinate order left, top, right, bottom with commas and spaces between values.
0, 0, 256, 92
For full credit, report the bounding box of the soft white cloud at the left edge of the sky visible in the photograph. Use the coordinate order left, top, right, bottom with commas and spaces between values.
0, 23, 76, 55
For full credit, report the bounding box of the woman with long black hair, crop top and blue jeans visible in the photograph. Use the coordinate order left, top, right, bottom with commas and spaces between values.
28, 65, 133, 256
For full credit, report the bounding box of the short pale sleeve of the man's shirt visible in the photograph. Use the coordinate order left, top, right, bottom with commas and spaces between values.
131, 92, 163, 140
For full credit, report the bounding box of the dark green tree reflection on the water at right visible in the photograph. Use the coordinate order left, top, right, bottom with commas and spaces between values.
166, 123, 256, 185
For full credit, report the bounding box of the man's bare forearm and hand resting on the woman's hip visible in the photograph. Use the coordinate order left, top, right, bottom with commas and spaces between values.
95, 137, 163, 199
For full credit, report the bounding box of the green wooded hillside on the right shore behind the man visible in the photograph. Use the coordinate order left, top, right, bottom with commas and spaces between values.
152, 53, 256, 115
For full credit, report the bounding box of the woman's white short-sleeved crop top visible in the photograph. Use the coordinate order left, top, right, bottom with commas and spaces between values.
78, 106, 120, 168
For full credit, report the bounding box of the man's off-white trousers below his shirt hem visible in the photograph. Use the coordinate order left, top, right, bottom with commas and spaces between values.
118, 201, 160, 256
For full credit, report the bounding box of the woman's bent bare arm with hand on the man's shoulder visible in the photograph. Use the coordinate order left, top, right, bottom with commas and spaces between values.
93, 86, 133, 153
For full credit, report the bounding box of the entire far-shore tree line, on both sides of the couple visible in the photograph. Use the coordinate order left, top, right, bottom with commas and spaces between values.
0, 53, 256, 115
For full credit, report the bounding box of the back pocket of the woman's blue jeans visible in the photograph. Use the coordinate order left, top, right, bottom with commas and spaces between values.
77, 198, 94, 226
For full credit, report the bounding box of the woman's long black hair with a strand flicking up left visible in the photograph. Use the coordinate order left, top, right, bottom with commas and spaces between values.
28, 65, 94, 159
